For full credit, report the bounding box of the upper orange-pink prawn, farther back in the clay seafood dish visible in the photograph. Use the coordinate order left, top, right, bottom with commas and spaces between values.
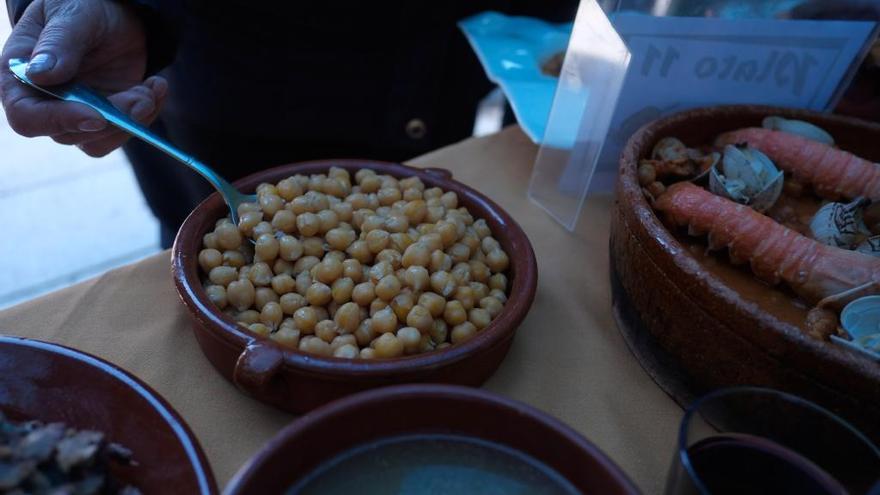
715, 127, 880, 201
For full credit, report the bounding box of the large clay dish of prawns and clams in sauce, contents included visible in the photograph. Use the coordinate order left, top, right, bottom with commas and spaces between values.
610, 106, 880, 438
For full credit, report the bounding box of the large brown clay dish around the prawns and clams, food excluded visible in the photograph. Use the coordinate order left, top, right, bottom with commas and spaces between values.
610, 105, 880, 440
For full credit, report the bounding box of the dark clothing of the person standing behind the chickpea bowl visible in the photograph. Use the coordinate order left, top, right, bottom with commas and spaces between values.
7, 0, 577, 248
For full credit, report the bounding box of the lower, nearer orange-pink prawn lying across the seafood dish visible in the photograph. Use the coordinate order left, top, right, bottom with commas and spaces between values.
654, 182, 880, 308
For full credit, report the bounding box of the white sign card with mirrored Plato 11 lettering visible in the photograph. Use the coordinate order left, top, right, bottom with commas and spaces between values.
536, 10, 876, 230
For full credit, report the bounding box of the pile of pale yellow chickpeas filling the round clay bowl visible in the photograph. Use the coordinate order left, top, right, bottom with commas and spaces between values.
198, 167, 509, 359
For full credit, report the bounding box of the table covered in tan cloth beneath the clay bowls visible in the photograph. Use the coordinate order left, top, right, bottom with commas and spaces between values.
0, 127, 682, 494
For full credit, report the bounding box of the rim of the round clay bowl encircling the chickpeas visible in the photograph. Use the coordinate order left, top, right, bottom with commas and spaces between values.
171, 159, 538, 380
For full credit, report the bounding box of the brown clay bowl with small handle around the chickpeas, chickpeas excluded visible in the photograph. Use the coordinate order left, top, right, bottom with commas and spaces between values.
171, 160, 538, 412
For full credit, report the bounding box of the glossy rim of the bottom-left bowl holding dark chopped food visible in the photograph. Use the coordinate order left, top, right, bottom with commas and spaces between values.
0, 334, 220, 494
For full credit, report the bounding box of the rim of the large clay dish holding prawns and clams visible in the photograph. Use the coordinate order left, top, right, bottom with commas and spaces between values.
617, 105, 880, 367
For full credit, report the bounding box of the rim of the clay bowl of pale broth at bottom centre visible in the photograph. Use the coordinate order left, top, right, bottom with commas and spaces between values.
223, 384, 641, 495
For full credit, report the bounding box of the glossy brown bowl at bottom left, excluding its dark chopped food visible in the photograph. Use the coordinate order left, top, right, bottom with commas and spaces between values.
0, 336, 217, 495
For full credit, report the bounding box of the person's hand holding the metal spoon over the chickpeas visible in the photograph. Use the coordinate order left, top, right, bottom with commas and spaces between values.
0, 0, 168, 156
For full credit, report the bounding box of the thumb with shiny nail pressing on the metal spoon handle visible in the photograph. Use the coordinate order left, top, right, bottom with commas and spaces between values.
27, 5, 95, 85
